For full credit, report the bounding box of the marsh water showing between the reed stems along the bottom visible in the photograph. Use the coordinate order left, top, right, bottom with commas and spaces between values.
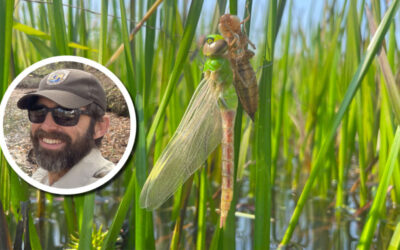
5, 164, 400, 249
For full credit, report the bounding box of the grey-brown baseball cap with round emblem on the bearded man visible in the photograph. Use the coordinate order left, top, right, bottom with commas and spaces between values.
17, 69, 107, 111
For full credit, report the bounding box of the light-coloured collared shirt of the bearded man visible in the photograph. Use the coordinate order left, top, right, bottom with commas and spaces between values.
32, 148, 114, 188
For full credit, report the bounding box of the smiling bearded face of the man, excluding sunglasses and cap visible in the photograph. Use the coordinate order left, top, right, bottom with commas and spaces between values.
31, 97, 95, 172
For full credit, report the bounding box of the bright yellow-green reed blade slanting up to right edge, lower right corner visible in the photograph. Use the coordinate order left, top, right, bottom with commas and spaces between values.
357, 127, 400, 249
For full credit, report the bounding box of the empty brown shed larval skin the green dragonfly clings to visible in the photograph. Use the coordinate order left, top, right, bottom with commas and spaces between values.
218, 14, 258, 121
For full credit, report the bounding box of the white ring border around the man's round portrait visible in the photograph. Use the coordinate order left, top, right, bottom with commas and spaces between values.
0, 56, 136, 195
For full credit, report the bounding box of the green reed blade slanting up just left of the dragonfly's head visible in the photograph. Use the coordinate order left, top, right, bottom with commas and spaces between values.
146, 0, 203, 149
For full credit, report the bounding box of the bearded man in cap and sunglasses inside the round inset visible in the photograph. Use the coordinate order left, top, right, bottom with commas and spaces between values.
17, 69, 114, 188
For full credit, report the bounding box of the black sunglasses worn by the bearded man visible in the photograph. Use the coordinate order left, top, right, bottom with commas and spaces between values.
28, 105, 90, 126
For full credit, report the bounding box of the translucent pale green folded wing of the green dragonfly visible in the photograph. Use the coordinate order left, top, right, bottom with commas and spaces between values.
140, 79, 222, 209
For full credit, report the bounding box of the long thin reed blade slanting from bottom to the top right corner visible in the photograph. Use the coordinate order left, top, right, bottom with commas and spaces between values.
280, 0, 399, 246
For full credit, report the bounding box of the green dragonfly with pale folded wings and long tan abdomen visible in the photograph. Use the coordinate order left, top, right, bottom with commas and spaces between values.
140, 35, 237, 227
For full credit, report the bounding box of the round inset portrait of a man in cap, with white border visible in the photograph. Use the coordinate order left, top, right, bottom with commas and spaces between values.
0, 56, 136, 195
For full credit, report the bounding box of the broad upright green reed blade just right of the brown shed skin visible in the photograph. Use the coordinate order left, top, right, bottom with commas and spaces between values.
254, 0, 280, 249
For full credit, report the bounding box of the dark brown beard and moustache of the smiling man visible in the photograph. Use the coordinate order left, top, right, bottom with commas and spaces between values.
31, 121, 95, 172
